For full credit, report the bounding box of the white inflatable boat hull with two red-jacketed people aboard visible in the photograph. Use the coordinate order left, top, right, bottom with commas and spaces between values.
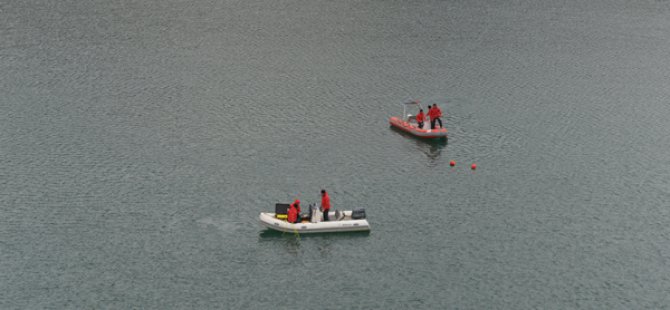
258, 211, 370, 234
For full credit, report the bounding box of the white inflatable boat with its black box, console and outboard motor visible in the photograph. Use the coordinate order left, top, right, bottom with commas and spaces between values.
258, 204, 370, 234
